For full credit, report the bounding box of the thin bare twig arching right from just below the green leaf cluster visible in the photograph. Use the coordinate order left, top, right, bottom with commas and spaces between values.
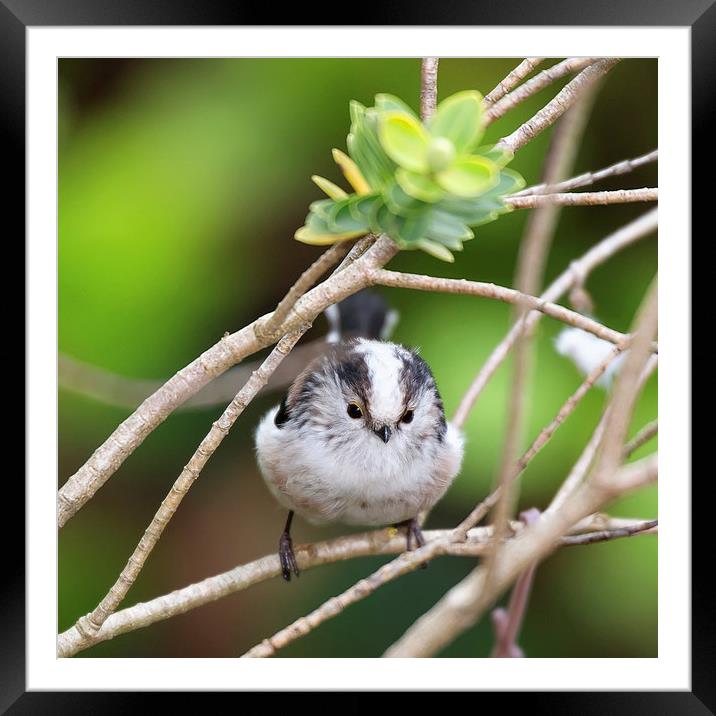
370, 269, 656, 350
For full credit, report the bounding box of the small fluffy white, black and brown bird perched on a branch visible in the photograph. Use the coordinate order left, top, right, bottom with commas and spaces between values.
255, 291, 463, 581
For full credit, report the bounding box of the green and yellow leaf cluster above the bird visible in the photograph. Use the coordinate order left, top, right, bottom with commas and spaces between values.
295, 90, 524, 261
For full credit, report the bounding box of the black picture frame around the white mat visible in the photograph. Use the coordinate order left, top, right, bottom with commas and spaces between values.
8, 0, 704, 714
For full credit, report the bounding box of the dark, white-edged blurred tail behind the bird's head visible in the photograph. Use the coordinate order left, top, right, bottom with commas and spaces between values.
325, 289, 399, 343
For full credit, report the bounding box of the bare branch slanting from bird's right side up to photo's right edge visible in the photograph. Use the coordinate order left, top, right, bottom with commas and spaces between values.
452, 209, 657, 427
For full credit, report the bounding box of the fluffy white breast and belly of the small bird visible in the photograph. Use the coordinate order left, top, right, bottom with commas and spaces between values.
256, 406, 463, 526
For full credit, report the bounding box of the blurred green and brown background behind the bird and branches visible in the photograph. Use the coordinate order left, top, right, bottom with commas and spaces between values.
58, 58, 657, 657
